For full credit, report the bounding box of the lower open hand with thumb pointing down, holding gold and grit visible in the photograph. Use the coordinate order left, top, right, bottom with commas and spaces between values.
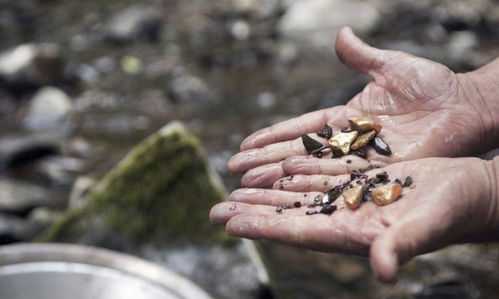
210, 158, 499, 282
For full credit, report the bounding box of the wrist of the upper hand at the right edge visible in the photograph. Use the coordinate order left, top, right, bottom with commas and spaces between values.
457, 58, 499, 153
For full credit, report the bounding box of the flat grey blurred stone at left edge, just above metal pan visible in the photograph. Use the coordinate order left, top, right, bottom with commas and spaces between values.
0, 178, 57, 214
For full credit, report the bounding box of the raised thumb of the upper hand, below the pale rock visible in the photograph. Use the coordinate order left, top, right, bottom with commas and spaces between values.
335, 27, 402, 77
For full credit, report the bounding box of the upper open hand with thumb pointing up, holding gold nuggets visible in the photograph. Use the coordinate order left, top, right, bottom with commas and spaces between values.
228, 28, 492, 187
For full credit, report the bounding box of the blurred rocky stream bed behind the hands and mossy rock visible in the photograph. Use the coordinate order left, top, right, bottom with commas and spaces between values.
0, 0, 499, 298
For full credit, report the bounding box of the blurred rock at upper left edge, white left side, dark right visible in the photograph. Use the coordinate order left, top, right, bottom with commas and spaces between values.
0, 43, 63, 89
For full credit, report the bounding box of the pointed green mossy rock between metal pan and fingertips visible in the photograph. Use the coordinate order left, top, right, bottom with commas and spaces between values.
39, 122, 230, 245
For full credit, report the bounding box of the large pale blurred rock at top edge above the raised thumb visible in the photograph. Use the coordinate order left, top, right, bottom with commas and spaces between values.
278, 0, 381, 51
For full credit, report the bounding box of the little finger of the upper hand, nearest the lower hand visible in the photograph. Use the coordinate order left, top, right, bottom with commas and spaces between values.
282, 155, 383, 175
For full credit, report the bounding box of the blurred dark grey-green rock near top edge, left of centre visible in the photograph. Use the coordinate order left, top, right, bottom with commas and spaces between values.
103, 4, 162, 44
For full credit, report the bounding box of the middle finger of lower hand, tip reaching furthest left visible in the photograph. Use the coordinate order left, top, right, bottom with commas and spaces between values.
210, 201, 316, 224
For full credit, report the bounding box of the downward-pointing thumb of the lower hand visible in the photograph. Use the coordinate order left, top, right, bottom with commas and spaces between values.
370, 209, 449, 283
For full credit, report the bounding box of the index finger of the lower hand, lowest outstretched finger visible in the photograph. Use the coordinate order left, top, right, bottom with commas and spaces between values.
226, 204, 381, 255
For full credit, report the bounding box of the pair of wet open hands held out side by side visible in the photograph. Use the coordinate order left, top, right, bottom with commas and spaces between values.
210, 28, 499, 283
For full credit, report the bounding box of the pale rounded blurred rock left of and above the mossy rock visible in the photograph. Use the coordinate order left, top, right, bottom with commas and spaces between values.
25, 87, 72, 131
